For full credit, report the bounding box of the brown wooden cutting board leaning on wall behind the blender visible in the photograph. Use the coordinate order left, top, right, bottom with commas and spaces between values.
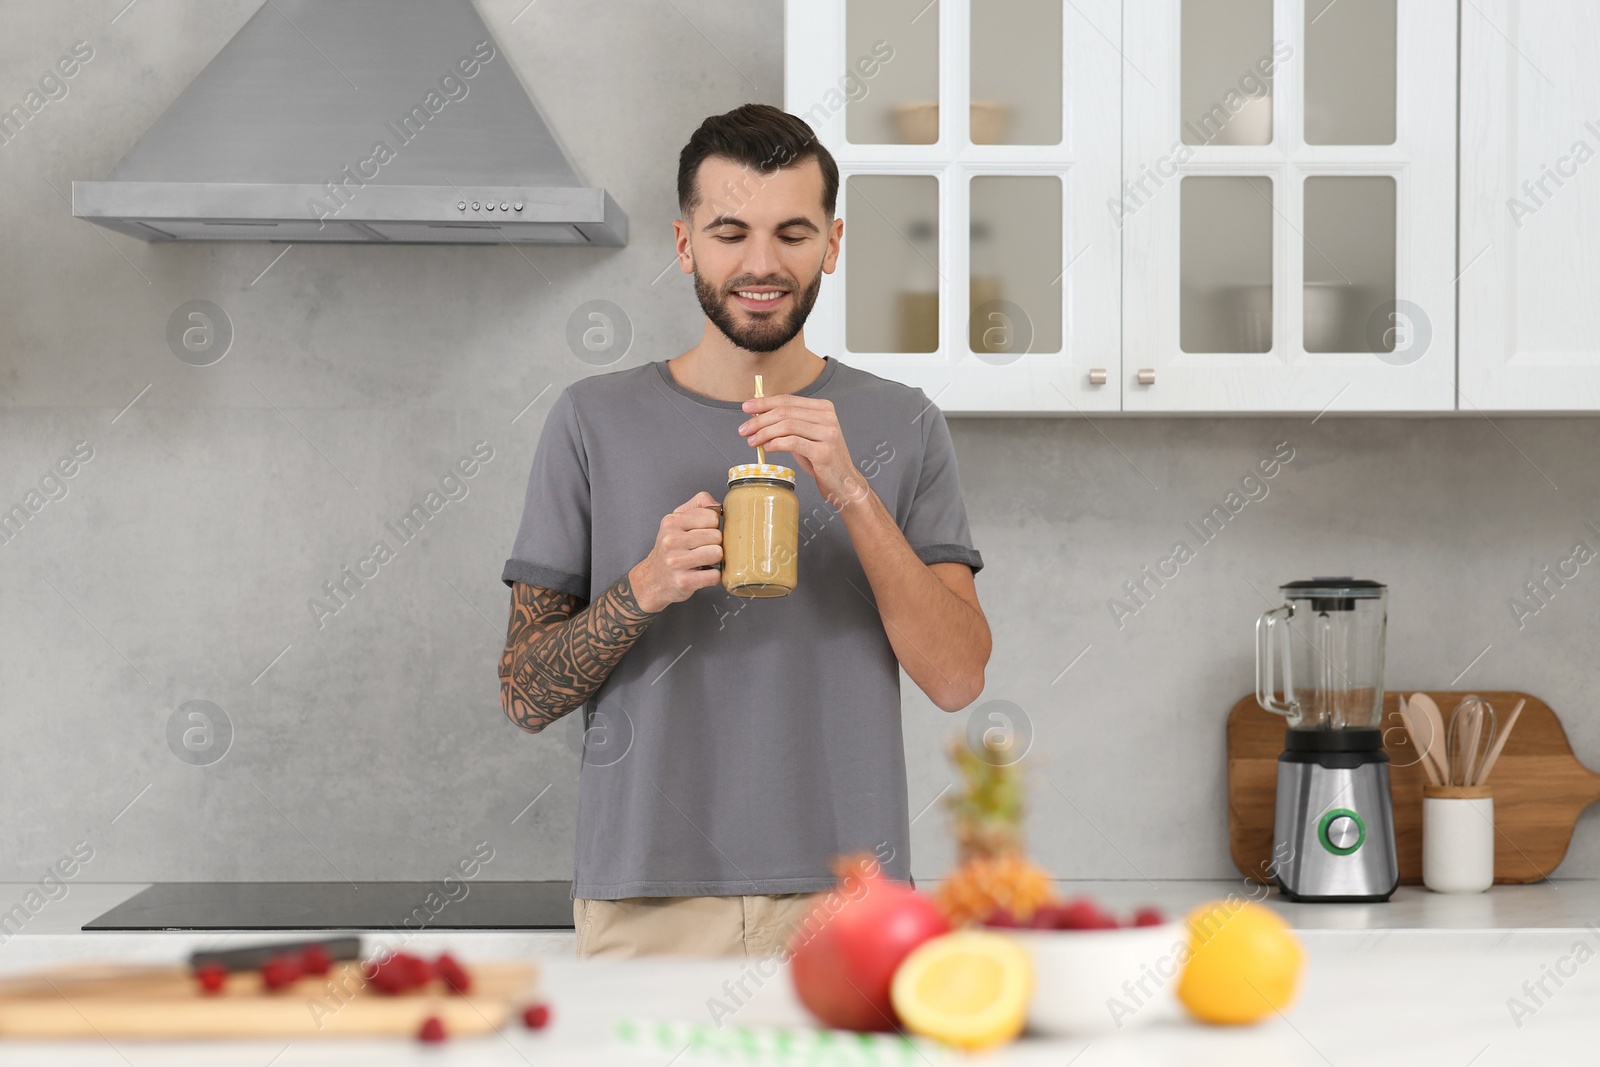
1227, 689, 1600, 885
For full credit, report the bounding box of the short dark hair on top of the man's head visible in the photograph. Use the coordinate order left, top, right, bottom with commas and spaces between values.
678, 104, 838, 221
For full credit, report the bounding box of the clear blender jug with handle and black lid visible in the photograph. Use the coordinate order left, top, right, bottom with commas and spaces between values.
1256, 577, 1389, 729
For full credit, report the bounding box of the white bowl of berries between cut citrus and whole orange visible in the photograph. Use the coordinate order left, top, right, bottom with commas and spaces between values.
997, 921, 1189, 1037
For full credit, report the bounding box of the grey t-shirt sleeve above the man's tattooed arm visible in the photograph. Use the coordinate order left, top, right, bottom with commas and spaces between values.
501, 389, 592, 600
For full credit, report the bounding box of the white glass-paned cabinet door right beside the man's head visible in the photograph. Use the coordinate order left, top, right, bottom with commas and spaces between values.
786, 0, 1123, 414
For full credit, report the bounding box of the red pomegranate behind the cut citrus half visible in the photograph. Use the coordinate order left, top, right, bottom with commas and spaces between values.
789, 853, 950, 1030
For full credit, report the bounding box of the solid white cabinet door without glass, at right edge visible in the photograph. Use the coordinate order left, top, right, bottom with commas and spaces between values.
1459, 0, 1600, 411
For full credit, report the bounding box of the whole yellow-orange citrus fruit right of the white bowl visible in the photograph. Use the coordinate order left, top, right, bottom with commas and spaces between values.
1178, 899, 1306, 1024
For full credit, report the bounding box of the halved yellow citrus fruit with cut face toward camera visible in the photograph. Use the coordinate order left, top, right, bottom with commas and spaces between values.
890, 929, 1034, 1049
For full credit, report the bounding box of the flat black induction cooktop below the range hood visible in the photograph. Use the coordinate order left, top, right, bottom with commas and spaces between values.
83, 880, 573, 929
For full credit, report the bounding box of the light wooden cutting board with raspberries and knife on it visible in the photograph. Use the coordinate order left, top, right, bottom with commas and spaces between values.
0, 963, 536, 1038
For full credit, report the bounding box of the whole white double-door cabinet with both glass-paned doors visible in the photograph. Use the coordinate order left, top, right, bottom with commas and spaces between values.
786, 0, 1458, 414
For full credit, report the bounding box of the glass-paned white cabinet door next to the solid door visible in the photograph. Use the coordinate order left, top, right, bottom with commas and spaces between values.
1118, 0, 1456, 413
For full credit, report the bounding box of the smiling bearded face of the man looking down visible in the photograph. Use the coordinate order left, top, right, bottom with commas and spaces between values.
675, 157, 845, 352
